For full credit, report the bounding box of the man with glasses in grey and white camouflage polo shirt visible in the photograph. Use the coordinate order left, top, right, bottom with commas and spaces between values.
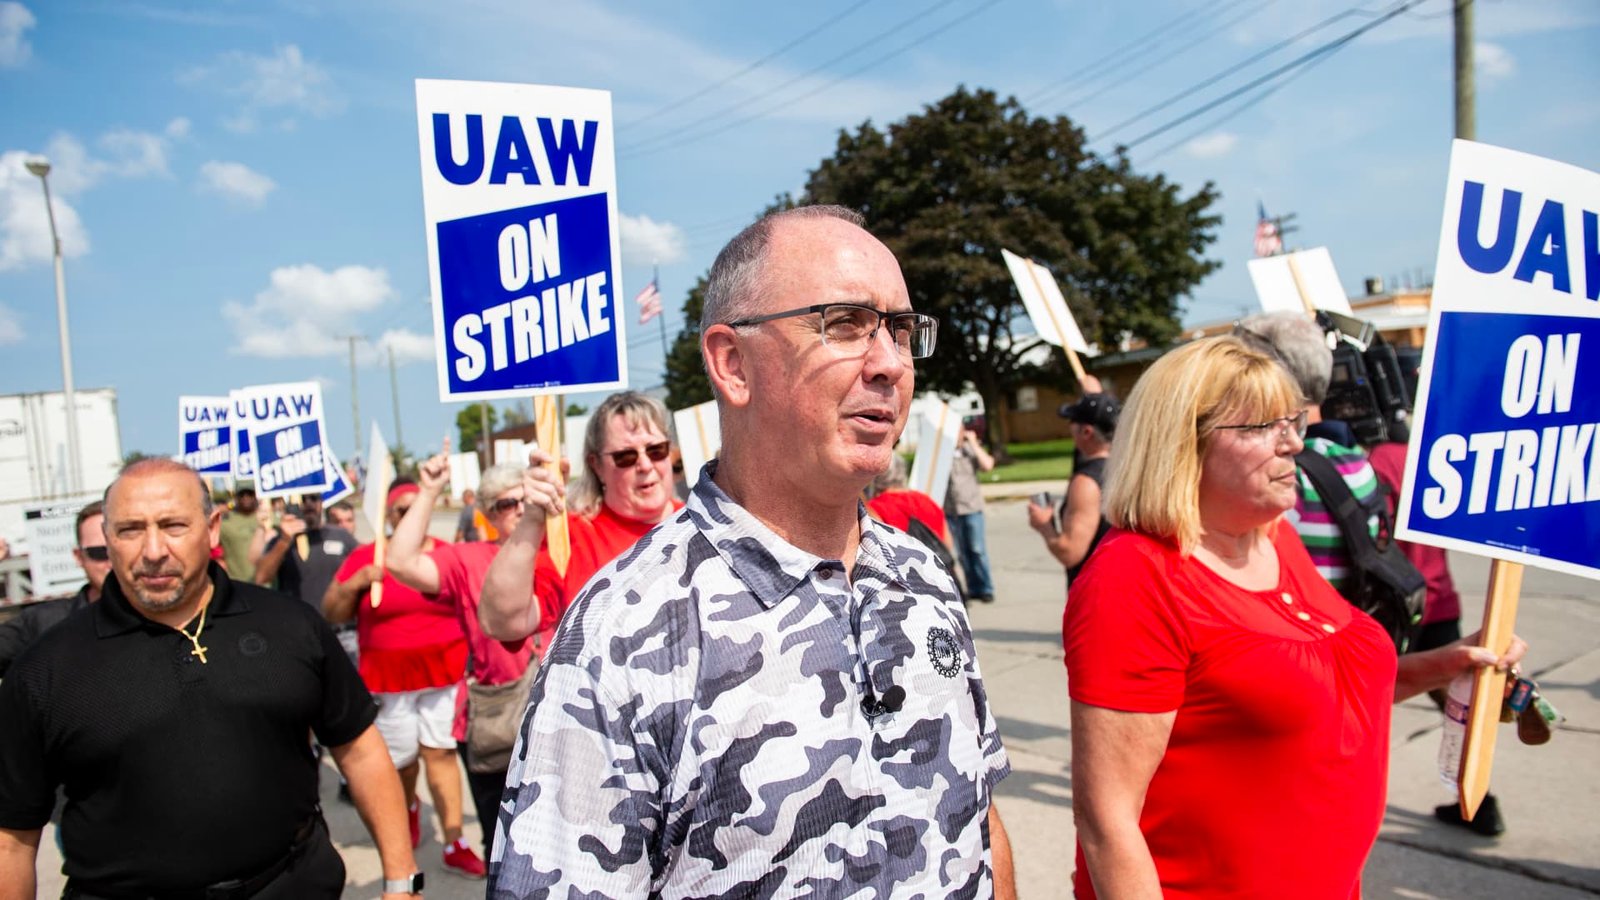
490, 207, 1014, 898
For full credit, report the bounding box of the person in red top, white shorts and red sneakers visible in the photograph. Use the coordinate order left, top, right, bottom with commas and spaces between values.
322, 480, 486, 878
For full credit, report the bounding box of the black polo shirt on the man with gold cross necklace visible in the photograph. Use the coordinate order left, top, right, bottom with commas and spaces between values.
0, 562, 376, 895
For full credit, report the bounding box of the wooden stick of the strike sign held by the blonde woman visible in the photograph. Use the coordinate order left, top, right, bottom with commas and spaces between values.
1456, 559, 1522, 822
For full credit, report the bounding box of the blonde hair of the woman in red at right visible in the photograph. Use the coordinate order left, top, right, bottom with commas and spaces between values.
1104, 335, 1304, 556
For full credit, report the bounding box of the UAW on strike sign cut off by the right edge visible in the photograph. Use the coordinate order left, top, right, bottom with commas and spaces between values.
1398, 141, 1600, 578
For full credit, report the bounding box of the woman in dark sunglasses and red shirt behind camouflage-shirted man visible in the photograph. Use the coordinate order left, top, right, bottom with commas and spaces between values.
478, 391, 683, 641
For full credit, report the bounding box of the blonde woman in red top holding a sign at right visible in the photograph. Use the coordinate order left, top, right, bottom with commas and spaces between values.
1062, 336, 1526, 900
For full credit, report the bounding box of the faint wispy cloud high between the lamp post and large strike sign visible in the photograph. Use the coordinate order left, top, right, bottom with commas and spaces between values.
178, 43, 344, 133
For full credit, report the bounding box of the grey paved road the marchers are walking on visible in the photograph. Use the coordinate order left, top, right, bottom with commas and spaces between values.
28, 496, 1600, 900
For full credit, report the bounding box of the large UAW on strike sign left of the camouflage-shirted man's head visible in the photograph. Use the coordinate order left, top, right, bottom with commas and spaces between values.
416, 80, 627, 400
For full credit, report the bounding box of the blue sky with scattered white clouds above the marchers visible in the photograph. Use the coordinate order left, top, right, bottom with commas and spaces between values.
0, 0, 1600, 455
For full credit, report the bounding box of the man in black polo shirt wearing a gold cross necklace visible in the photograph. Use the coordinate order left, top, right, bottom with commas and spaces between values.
0, 460, 419, 900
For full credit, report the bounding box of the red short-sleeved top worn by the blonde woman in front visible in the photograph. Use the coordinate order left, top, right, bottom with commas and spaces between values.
1062, 522, 1395, 900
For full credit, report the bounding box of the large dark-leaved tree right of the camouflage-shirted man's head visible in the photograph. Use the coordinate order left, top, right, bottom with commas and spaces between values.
803, 86, 1219, 445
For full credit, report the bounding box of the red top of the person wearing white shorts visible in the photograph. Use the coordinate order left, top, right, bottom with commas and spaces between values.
333, 544, 467, 693
